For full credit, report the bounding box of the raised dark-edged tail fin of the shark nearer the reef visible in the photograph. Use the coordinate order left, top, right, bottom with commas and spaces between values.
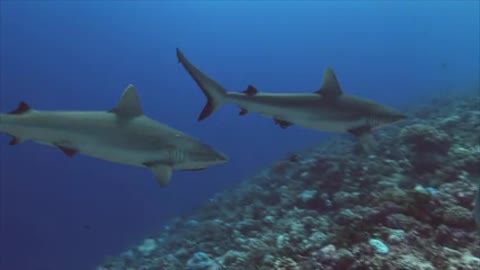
177, 48, 227, 121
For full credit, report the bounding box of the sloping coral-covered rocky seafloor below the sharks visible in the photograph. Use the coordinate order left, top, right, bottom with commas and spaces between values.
97, 94, 480, 270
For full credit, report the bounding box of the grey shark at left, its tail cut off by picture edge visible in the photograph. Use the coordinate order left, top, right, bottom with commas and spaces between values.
0, 85, 228, 186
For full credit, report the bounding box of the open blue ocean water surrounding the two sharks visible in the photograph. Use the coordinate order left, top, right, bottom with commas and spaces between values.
0, 1, 480, 270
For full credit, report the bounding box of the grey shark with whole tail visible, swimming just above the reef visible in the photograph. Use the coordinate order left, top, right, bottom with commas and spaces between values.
177, 48, 406, 141
